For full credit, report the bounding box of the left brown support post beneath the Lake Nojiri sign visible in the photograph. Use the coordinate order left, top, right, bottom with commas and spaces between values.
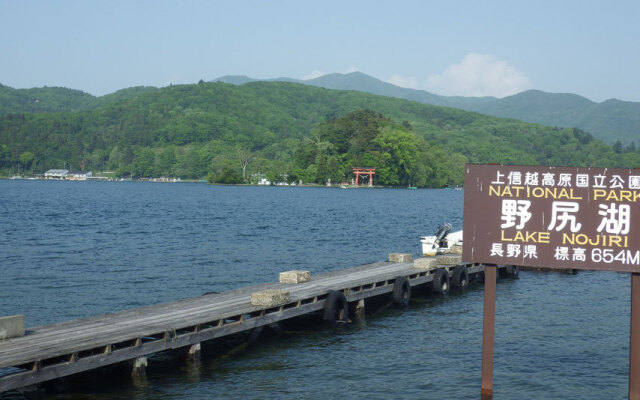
480, 264, 498, 398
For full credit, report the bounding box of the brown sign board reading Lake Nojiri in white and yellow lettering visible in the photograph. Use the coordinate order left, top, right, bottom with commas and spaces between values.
462, 164, 640, 272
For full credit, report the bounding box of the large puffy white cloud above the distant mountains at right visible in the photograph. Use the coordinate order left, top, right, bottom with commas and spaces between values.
424, 53, 532, 97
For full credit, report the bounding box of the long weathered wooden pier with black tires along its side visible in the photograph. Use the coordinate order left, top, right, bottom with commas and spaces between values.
0, 254, 517, 393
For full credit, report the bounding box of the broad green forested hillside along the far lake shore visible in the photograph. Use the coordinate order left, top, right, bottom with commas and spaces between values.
0, 81, 640, 187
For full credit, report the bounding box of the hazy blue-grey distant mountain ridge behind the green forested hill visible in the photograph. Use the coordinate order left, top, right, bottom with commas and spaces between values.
214, 72, 640, 144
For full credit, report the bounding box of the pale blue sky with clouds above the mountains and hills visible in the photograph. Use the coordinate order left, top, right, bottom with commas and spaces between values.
0, 0, 640, 102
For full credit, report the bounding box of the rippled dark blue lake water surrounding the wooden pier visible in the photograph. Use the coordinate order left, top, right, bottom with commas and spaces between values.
0, 180, 630, 399
